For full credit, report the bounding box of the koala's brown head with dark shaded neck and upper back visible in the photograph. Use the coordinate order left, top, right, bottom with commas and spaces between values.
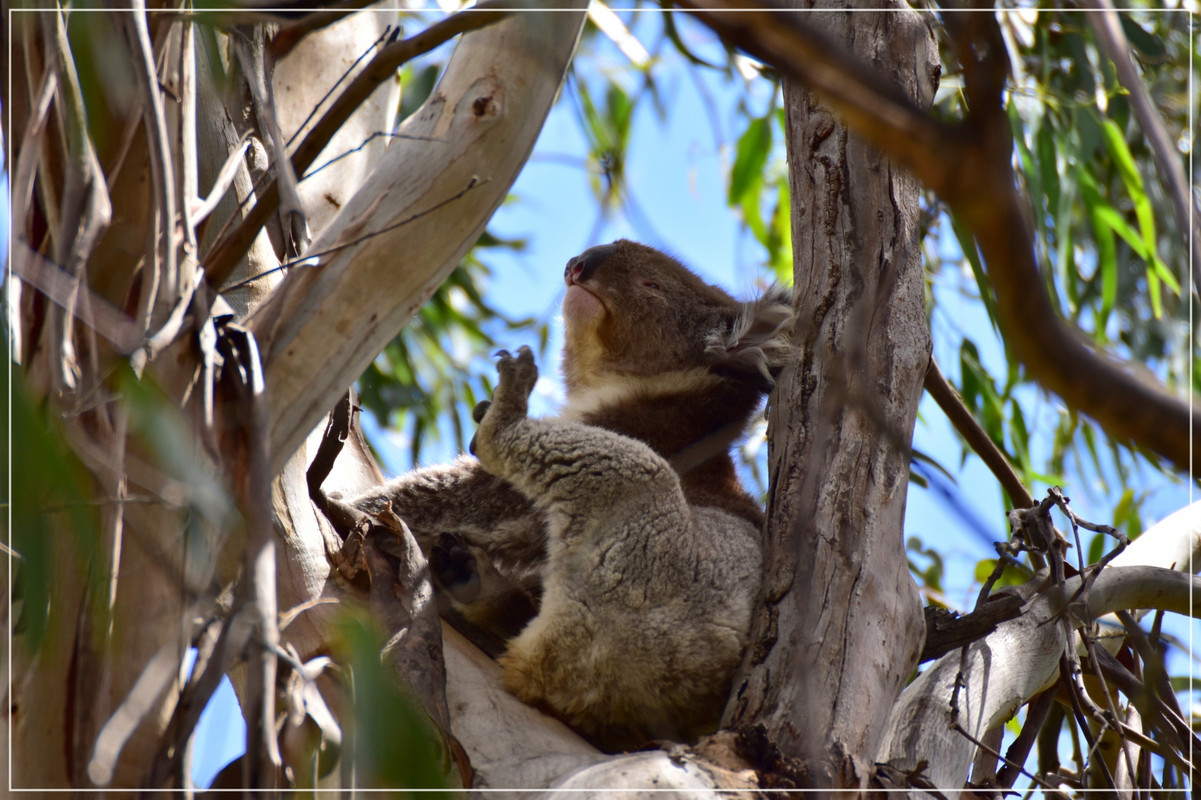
562, 240, 793, 525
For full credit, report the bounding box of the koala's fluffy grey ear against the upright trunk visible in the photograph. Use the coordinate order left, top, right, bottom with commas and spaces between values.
705, 285, 794, 393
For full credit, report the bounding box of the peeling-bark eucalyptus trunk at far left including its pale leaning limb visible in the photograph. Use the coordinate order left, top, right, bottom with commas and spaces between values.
8, 2, 582, 789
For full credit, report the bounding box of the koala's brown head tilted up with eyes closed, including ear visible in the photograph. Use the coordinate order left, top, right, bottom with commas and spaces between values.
563, 239, 793, 393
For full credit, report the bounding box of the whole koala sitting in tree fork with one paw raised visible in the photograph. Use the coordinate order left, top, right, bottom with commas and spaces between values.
352, 240, 793, 751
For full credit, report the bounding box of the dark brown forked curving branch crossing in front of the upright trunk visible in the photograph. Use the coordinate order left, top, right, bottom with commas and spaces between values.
680, 0, 1201, 474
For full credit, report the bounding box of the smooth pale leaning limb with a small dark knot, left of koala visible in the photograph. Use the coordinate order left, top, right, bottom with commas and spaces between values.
247, 6, 586, 470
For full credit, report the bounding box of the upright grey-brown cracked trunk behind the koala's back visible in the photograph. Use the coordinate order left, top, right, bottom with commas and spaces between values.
727, 4, 937, 787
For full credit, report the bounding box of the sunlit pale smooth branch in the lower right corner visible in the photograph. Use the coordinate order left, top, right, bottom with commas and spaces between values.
877, 503, 1201, 798
